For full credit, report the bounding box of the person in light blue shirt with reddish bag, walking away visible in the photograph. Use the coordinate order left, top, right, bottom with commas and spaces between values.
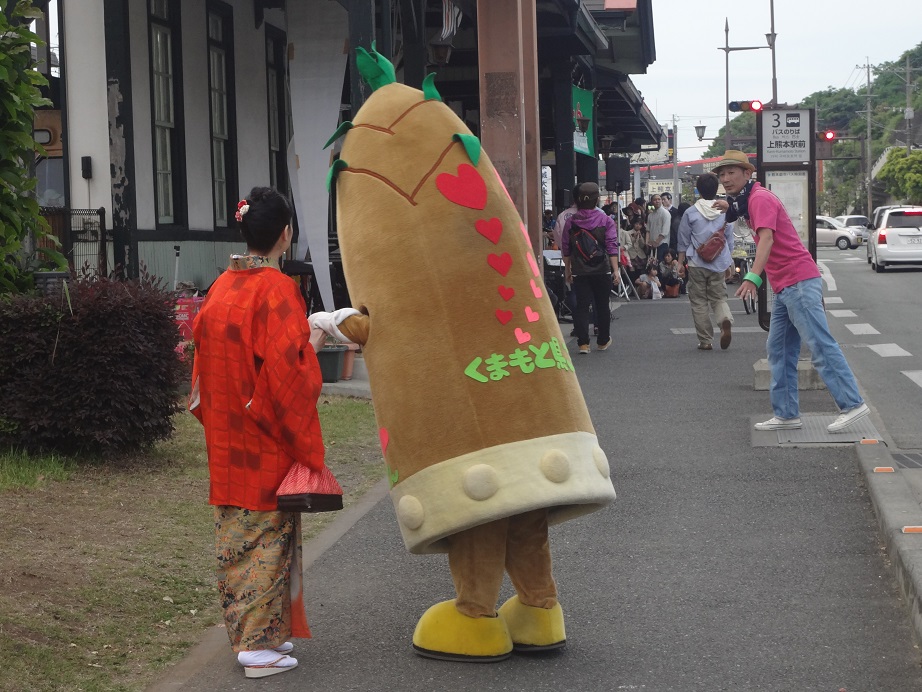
678, 173, 733, 351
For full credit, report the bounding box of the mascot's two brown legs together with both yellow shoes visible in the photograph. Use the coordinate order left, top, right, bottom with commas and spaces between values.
413, 509, 566, 662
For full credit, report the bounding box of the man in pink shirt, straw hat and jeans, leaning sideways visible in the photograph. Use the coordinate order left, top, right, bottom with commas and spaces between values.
714, 149, 869, 433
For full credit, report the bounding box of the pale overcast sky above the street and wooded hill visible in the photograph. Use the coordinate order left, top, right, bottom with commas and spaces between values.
631, 0, 922, 161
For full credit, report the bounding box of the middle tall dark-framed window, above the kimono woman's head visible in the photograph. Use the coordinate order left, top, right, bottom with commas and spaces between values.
208, 3, 237, 227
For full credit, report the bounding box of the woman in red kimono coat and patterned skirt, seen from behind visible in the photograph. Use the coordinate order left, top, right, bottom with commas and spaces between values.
189, 188, 325, 677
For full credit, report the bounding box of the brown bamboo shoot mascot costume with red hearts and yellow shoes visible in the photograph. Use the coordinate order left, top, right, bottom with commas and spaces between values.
311, 48, 615, 661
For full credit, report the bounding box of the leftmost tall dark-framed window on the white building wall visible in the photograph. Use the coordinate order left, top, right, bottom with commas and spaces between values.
150, 0, 183, 225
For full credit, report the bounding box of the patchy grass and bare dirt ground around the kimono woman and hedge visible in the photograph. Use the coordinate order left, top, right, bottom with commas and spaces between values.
0, 396, 383, 692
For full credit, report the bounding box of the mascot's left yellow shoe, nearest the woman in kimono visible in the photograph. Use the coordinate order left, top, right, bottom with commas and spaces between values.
413, 599, 512, 663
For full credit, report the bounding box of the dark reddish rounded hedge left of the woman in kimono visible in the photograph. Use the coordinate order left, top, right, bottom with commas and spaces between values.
0, 278, 185, 456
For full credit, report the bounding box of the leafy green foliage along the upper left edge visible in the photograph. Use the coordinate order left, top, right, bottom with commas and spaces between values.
0, 0, 63, 293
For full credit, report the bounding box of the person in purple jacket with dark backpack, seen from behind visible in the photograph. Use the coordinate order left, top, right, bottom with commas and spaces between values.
560, 183, 621, 355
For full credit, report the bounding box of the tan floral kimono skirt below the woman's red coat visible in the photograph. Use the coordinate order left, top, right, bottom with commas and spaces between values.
214, 505, 311, 652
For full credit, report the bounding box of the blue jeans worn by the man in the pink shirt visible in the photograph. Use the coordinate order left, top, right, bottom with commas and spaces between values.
766, 278, 864, 418
